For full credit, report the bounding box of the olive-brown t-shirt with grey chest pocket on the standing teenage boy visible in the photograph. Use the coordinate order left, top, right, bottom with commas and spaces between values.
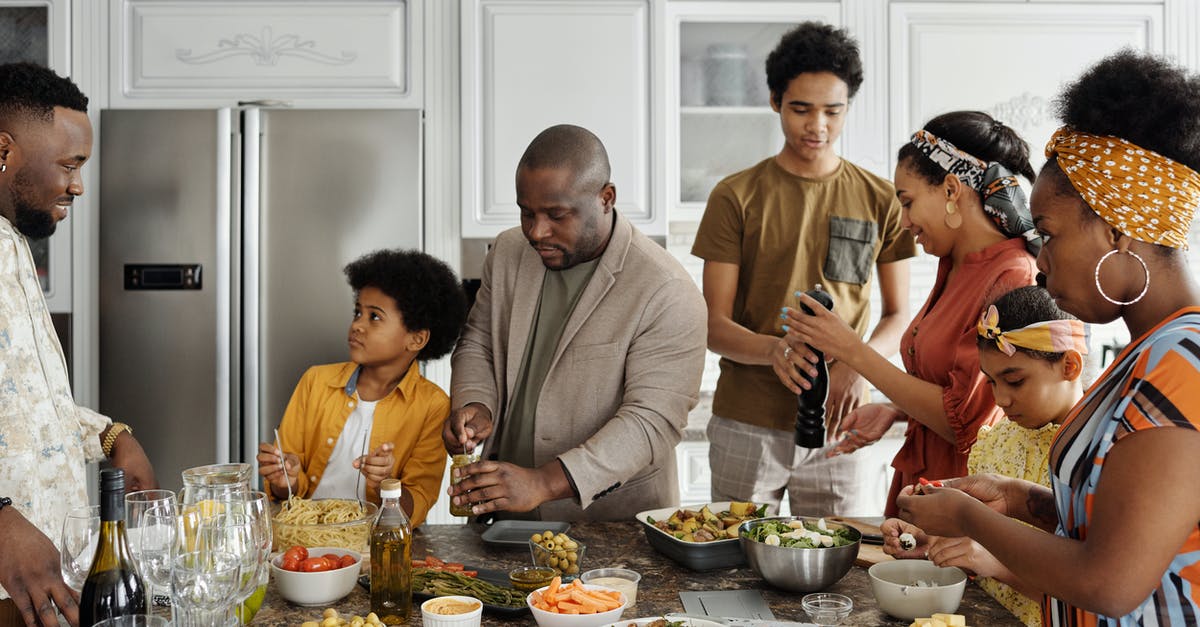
691, 157, 917, 430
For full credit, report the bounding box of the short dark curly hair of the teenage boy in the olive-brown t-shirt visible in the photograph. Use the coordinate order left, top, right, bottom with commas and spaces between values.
767, 22, 863, 105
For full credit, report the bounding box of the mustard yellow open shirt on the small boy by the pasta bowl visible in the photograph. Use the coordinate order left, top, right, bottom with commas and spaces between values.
280, 362, 450, 529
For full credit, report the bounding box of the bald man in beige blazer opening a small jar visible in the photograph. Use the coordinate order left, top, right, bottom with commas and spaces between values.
443, 125, 707, 520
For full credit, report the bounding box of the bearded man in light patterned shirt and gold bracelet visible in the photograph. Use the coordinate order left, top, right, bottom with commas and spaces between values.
0, 64, 155, 627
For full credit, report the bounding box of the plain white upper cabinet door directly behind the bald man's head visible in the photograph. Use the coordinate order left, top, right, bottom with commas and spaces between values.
462, 0, 666, 238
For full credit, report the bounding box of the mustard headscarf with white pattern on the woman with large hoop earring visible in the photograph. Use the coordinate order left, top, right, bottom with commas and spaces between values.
1045, 126, 1200, 249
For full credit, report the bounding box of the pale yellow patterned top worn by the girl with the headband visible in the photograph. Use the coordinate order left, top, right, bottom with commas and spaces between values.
967, 418, 1058, 627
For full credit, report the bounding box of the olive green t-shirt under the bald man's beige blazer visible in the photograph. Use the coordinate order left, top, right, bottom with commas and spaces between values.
497, 257, 600, 468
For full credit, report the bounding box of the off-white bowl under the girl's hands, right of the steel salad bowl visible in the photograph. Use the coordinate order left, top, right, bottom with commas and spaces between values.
866, 560, 967, 620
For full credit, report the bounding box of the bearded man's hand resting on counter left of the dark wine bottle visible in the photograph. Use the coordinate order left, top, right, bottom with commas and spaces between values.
0, 506, 79, 627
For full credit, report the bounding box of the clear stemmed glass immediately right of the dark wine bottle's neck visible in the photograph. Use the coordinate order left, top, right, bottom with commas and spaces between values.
125, 490, 179, 607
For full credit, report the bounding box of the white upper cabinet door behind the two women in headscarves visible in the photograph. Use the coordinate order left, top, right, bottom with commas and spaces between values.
890, 2, 1163, 168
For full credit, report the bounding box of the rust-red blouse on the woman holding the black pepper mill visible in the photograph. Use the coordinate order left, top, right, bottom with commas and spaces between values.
884, 238, 1037, 516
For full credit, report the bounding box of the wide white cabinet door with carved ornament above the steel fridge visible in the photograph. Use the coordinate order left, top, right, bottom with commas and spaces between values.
109, 0, 422, 108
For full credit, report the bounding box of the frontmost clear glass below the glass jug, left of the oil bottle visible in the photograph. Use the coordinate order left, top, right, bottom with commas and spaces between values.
170, 550, 241, 627
